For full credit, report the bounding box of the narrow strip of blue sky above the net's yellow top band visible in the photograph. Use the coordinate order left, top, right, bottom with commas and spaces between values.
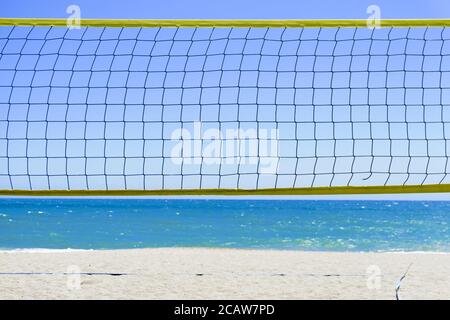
0, 0, 450, 19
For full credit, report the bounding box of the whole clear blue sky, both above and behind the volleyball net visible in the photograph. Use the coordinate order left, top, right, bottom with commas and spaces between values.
0, 0, 450, 194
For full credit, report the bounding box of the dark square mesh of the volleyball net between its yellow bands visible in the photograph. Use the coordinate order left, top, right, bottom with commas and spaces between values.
0, 27, 450, 190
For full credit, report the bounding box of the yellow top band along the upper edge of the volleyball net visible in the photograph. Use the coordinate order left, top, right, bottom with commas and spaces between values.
0, 18, 450, 28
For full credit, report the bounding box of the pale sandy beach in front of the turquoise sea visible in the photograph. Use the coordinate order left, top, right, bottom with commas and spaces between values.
0, 248, 450, 299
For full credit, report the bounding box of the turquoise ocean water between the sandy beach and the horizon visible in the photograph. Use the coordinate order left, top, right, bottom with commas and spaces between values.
0, 198, 450, 252
